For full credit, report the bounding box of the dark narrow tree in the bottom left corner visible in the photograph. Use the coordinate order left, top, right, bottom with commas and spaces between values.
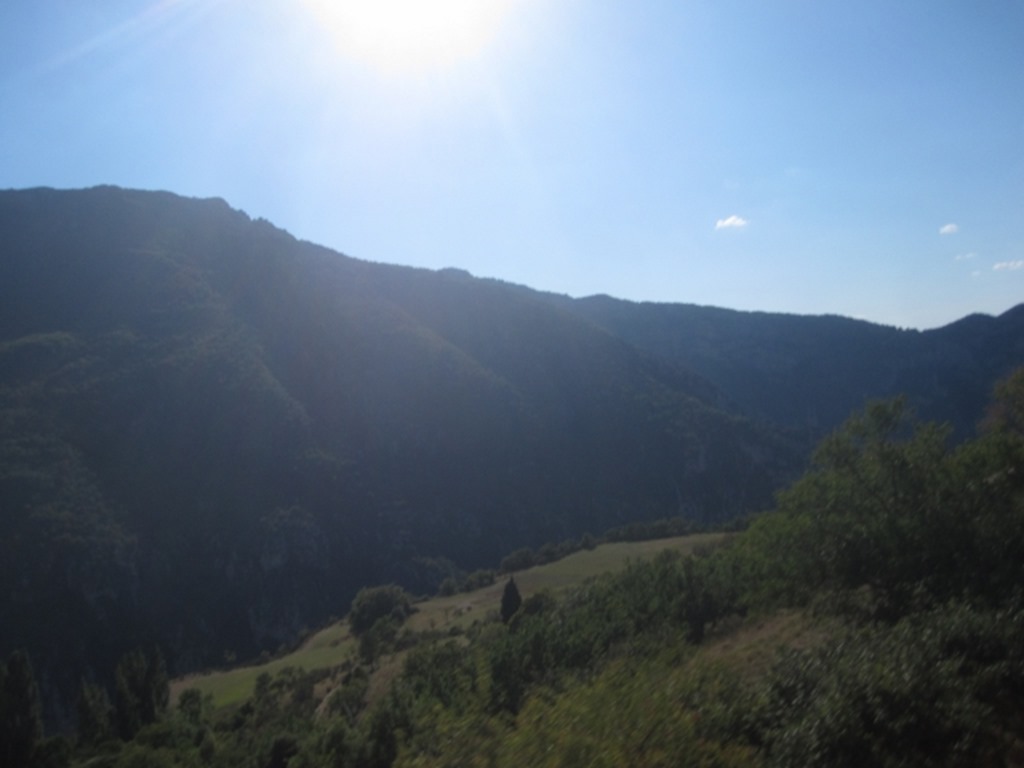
0, 650, 43, 766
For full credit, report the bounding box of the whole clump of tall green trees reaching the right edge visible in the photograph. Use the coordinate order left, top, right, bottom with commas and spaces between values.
733, 391, 1024, 621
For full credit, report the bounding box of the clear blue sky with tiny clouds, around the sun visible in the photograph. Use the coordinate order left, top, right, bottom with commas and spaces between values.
0, 0, 1024, 328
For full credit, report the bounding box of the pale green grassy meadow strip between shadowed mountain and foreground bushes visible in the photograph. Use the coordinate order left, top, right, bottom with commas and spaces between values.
171, 534, 726, 708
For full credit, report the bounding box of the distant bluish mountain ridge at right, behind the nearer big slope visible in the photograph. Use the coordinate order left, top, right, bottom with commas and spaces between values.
557, 296, 1024, 437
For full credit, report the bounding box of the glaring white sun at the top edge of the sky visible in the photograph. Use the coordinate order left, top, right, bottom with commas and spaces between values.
305, 0, 513, 73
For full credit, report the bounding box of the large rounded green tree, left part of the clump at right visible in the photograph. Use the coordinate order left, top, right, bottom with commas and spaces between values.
754, 399, 946, 615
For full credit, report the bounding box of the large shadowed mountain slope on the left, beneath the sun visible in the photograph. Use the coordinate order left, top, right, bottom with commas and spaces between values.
0, 187, 801, 720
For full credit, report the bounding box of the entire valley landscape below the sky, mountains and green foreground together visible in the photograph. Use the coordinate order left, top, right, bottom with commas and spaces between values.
0, 186, 1024, 768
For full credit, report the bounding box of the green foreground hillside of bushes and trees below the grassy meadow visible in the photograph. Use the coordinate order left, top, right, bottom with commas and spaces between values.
8, 370, 1024, 768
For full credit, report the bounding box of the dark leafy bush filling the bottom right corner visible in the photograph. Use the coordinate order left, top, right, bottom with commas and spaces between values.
757, 603, 1024, 766
